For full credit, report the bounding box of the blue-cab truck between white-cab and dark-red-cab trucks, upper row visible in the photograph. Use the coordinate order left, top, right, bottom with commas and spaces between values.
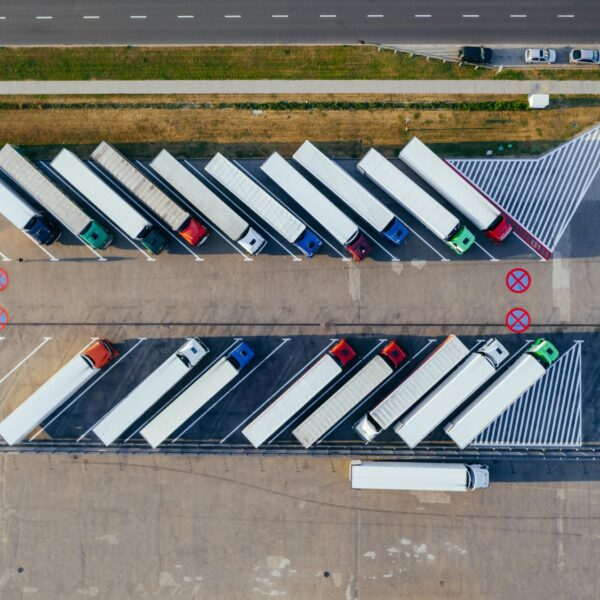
205, 153, 323, 257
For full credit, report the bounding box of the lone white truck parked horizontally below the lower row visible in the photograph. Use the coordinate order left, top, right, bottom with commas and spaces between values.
350, 460, 490, 492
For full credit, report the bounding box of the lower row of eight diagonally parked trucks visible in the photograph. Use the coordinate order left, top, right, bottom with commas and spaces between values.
0, 335, 559, 449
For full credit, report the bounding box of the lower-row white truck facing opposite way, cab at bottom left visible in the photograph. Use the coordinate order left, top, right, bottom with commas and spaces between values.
354, 335, 469, 442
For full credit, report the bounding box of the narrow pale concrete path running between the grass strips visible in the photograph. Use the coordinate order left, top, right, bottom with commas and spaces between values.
0, 79, 600, 96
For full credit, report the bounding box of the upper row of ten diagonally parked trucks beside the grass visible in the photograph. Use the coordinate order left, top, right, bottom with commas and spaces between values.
0, 138, 511, 261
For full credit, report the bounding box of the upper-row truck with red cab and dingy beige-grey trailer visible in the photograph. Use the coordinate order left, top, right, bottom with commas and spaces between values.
91, 142, 208, 246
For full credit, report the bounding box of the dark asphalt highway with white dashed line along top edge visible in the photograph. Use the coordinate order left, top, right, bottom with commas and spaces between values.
0, 0, 600, 45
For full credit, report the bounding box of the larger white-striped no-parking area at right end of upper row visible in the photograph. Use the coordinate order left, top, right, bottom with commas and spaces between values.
449, 127, 600, 258
